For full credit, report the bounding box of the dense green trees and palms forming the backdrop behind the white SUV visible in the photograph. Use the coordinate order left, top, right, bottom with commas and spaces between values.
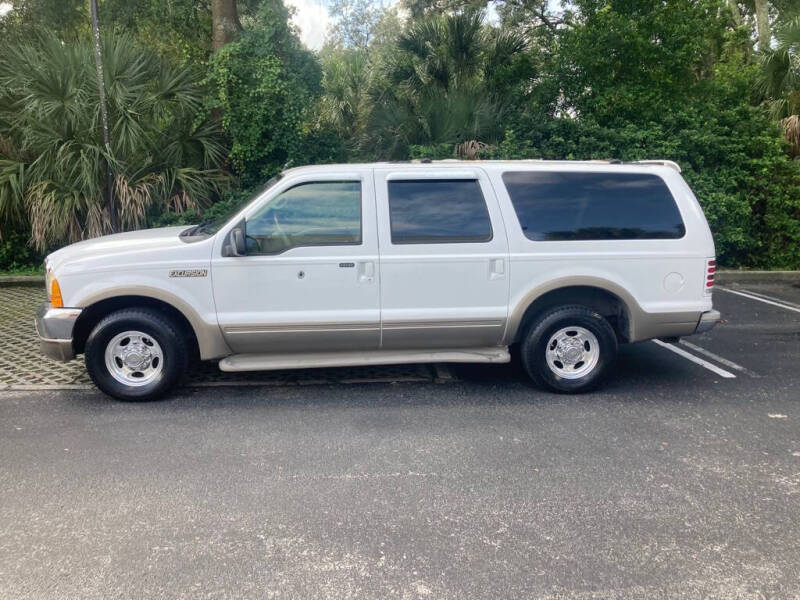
0, 0, 800, 269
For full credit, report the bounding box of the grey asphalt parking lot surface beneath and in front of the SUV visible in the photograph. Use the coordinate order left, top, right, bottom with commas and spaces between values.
0, 283, 800, 599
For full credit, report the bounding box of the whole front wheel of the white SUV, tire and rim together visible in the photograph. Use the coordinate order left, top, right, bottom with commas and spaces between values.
85, 308, 189, 401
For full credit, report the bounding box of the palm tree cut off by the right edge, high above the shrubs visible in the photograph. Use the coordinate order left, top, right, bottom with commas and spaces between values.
759, 15, 800, 156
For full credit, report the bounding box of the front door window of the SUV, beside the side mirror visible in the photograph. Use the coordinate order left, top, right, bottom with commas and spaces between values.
247, 181, 361, 254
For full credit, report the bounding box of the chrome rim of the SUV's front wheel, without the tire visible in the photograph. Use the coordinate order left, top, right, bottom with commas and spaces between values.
105, 331, 164, 387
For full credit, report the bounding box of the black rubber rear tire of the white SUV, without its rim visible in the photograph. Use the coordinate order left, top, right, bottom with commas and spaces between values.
520, 305, 617, 394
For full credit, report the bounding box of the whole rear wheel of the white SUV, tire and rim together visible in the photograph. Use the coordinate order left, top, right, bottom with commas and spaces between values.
521, 306, 617, 393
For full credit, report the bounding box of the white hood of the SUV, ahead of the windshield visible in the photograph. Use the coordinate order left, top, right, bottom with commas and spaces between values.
46, 225, 195, 270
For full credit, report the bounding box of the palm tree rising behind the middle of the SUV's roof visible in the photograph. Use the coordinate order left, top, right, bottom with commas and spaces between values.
372, 9, 527, 156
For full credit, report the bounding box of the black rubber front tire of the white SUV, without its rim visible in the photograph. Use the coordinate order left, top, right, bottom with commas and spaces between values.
85, 308, 190, 402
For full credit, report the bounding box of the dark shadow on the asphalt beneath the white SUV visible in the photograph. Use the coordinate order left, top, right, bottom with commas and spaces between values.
61, 343, 744, 413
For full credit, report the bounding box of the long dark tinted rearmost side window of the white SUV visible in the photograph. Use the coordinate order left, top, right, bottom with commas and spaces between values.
503, 171, 686, 241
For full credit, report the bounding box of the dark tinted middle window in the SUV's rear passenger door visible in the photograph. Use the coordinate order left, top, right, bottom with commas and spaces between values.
389, 179, 492, 244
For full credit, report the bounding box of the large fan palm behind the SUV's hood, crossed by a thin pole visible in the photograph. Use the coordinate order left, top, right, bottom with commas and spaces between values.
0, 34, 227, 249
